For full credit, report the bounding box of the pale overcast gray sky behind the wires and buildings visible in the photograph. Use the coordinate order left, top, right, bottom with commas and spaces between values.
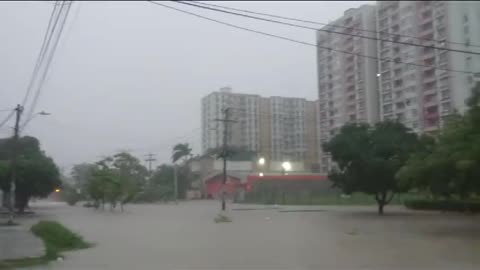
0, 1, 373, 171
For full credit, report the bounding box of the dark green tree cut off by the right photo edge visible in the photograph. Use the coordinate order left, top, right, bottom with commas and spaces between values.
397, 83, 480, 199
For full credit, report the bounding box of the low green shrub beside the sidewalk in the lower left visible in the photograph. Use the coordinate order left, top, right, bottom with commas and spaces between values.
31, 221, 90, 259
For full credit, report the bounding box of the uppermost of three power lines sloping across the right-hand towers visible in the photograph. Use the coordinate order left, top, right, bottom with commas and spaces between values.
189, 1, 480, 48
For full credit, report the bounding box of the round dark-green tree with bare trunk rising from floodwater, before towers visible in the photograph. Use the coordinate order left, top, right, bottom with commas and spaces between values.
323, 121, 418, 214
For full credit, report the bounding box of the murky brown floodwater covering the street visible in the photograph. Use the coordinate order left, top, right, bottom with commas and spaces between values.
25, 201, 480, 270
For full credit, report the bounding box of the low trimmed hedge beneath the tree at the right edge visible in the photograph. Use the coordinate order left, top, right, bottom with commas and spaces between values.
405, 200, 480, 213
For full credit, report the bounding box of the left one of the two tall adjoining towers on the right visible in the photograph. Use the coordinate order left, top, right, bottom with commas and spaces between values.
317, 5, 379, 172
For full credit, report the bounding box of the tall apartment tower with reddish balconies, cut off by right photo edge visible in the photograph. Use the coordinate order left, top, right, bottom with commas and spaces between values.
377, 1, 480, 132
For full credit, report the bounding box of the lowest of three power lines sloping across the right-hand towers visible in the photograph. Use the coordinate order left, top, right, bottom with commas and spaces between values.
148, 1, 475, 74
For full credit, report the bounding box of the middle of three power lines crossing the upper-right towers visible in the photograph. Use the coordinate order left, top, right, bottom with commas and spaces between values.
173, 1, 480, 55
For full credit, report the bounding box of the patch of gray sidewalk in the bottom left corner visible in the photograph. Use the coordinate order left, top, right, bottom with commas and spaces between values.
0, 215, 44, 260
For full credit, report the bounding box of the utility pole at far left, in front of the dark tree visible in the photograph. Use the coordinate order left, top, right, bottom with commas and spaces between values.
7, 104, 23, 225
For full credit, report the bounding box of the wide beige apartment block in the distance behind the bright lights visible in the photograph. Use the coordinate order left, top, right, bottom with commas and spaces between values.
202, 88, 318, 168
